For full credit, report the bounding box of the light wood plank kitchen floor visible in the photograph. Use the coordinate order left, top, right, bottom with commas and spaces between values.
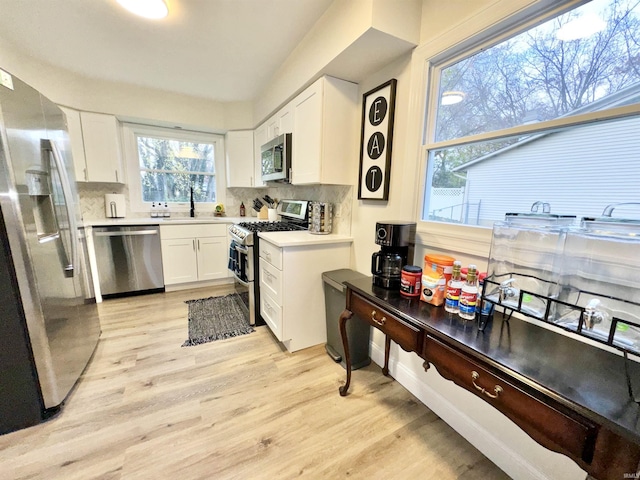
0, 287, 508, 480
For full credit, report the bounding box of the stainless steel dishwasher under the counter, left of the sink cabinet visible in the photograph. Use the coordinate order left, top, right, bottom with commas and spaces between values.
93, 225, 164, 298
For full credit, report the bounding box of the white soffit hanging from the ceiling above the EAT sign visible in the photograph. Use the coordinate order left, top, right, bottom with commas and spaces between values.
254, 0, 421, 125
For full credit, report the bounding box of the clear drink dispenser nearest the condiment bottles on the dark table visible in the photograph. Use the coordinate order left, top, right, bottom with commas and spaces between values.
481, 213, 576, 319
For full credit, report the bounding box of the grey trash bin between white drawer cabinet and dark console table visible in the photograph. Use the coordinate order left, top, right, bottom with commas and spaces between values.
322, 268, 371, 370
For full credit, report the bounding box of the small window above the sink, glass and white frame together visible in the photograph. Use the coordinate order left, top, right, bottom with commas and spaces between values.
123, 124, 224, 211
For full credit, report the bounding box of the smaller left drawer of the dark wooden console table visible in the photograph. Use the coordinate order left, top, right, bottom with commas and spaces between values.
349, 294, 423, 352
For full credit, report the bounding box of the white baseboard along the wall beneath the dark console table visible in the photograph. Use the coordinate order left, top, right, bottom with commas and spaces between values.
371, 342, 586, 480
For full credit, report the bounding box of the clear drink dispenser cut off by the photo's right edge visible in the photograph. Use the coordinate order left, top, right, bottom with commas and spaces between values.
553, 217, 640, 353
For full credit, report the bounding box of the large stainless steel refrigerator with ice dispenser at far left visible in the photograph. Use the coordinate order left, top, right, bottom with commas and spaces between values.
0, 71, 100, 434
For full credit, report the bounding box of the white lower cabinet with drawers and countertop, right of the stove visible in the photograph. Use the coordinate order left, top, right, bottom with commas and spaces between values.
259, 238, 351, 352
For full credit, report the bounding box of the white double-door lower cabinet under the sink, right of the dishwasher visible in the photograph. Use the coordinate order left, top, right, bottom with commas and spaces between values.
160, 224, 229, 285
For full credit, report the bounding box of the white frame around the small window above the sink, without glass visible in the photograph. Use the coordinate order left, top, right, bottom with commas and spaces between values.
122, 123, 226, 213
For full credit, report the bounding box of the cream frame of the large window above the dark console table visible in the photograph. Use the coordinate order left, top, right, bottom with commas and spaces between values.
411, 0, 640, 258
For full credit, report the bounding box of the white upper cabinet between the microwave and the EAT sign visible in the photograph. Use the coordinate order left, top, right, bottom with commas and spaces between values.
290, 77, 359, 185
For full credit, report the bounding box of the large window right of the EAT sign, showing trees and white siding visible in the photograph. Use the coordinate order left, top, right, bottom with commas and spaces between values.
421, 0, 640, 234
